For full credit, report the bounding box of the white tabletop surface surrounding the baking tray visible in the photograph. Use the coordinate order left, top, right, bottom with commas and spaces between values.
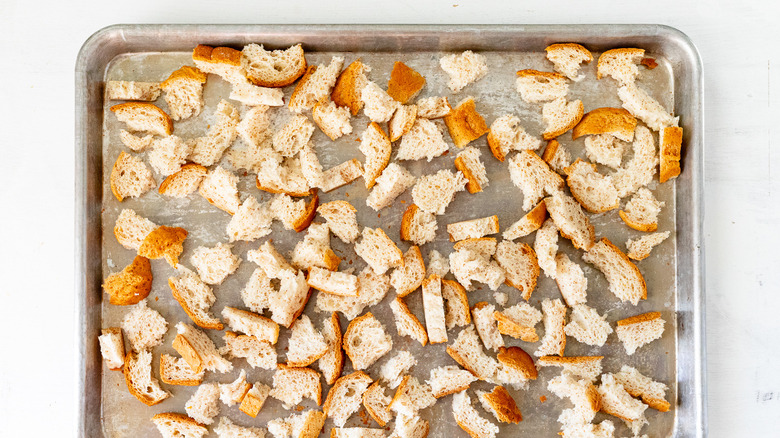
0, 0, 780, 437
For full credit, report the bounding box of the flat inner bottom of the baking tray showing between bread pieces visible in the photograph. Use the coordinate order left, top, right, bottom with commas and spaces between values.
74, 24, 708, 436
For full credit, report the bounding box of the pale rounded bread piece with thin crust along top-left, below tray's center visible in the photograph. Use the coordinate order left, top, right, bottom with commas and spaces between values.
344, 312, 393, 370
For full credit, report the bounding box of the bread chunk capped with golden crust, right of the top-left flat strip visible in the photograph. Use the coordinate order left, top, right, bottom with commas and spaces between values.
160, 65, 207, 120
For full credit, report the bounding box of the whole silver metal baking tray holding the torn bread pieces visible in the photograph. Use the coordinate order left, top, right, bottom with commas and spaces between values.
75, 25, 706, 437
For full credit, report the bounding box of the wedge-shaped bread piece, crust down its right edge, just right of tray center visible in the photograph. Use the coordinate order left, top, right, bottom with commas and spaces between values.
494, 240, 539, 301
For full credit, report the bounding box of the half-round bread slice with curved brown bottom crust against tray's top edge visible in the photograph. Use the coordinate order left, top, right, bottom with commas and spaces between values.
241, 44, 306, 87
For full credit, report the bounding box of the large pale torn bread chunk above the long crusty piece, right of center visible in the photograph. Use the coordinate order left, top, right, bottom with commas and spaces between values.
509, 150, 564, 211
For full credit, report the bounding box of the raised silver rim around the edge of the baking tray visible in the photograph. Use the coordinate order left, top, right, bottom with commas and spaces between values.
74, 23, 708, 437
